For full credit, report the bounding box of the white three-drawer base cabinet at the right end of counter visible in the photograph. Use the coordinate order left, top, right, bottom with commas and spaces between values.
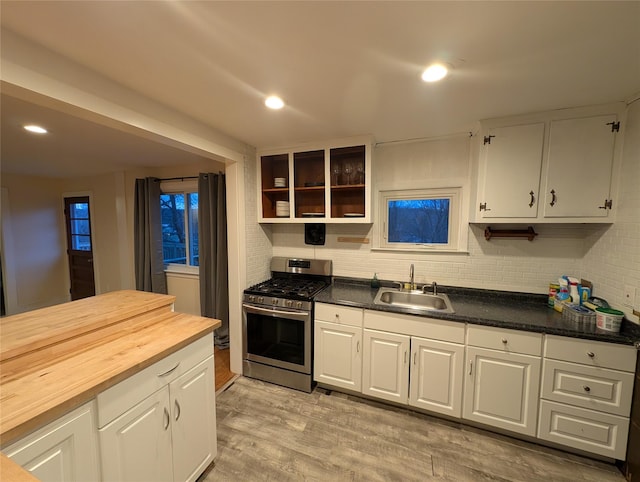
538, 336, 637, 460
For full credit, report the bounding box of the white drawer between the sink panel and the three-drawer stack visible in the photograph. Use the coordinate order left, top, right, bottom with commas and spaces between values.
467, 325, 542, 356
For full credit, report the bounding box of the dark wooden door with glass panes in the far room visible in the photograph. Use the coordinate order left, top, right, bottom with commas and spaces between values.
64, 196, 96, 300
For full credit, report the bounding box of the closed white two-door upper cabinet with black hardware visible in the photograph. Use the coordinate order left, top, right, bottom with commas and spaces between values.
471, 104, 624, 223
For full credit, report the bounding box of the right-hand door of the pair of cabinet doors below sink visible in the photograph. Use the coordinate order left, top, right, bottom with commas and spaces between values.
409, 337, 464, 418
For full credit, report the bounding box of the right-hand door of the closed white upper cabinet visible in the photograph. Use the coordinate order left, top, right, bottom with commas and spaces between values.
544, 114, 616, 217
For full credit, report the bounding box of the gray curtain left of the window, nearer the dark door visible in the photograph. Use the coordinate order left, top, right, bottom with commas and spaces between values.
133, 177, 167, 293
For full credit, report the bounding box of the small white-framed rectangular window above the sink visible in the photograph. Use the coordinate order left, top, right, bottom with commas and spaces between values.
378, 188, 461, 251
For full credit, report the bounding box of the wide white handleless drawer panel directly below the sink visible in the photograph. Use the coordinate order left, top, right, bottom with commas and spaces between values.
364, 310, 465, 343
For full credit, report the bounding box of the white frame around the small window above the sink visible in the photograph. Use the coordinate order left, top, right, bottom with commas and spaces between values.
373, 185, 467, 253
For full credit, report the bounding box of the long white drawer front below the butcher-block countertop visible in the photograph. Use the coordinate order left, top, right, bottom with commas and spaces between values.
96, 335, 213, 428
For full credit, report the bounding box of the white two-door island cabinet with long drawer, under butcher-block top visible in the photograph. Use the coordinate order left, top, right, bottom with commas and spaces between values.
98, 337, 217, 482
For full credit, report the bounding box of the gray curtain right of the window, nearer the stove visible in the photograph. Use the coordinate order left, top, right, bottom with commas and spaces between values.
198, 173, 229, 349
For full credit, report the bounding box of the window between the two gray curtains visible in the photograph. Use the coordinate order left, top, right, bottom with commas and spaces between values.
160, 192, 200, 266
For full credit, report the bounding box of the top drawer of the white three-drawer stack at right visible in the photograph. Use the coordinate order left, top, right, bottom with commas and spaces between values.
544, 335, 637, 372
